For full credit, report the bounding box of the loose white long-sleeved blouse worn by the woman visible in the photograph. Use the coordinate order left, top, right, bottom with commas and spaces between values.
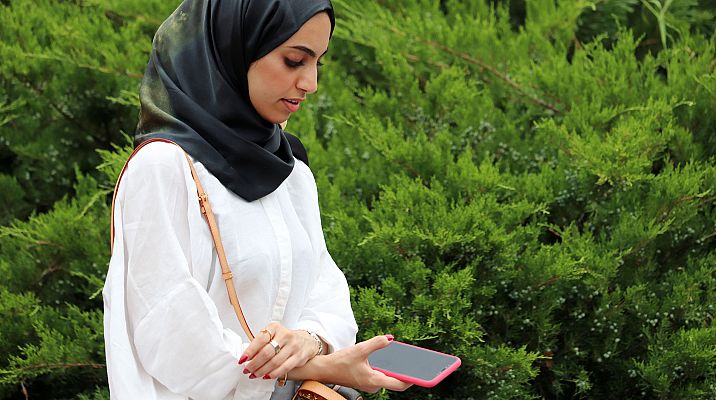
103, 142, 357, 400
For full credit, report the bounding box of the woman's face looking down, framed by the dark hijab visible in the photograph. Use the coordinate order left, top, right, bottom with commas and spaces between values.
247, 12, 331, 124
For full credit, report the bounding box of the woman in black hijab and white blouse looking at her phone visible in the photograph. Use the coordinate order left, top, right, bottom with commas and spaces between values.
103, 0, 408, 399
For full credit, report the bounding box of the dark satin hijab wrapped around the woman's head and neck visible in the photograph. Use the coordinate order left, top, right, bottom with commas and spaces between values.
134, 0, 335, 201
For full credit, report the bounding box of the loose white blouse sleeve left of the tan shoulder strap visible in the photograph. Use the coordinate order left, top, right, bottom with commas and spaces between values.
115, 144, 247, 399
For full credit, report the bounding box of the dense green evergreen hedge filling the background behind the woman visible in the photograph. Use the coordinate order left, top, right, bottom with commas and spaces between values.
0, 0, 716, 399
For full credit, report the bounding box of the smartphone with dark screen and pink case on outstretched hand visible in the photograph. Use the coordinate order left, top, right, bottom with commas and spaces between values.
368, 341, 461, 387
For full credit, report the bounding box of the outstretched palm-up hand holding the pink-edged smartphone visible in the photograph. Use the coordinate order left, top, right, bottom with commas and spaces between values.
288, 336, 412, 393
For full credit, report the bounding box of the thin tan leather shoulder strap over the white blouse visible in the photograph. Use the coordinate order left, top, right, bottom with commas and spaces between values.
110, 139, 254, 340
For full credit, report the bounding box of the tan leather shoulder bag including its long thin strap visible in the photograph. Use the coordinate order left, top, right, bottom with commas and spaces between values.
110, 138, 362, 400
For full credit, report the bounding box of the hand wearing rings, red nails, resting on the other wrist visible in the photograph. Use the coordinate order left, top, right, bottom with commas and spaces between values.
239, 322, 318, 379
